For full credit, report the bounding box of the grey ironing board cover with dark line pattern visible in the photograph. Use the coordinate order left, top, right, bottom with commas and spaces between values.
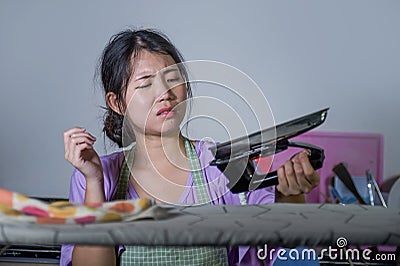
0, 204, 400, 246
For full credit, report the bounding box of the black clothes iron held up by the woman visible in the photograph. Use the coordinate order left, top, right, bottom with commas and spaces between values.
210, 108, 328, 193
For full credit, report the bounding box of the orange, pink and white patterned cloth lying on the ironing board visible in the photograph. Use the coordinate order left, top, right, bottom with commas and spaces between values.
0, 189, 154, 224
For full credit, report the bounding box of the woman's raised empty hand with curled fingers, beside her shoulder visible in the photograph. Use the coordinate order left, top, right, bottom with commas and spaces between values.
64, 127, 103, 182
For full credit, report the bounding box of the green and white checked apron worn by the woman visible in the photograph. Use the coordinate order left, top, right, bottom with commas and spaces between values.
117, 139, 228, 266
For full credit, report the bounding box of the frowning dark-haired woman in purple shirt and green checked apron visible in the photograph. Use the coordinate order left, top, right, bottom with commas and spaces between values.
61, 30, 319, 265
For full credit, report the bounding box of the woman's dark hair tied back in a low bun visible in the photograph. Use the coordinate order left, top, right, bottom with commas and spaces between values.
98, 29, 192, 147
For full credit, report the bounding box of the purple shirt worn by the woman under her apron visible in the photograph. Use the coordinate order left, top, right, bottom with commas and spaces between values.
60, 141, 275, 266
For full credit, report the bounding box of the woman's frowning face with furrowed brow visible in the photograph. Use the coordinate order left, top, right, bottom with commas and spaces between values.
125, 50, 186, 137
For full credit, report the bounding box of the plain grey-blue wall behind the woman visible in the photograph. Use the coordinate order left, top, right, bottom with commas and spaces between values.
0, 0, 400, 197
